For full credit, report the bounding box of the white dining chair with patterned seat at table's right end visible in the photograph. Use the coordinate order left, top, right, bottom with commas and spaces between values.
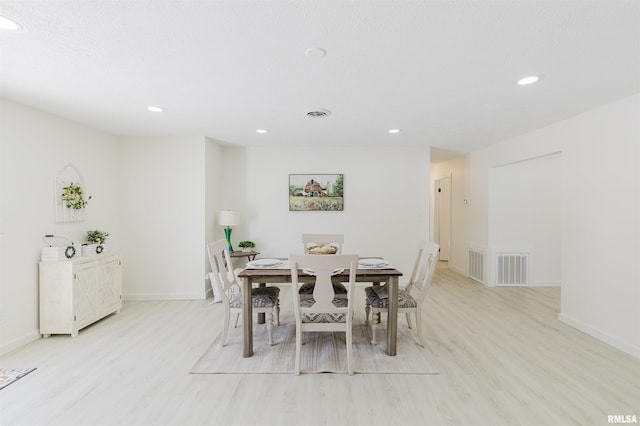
364, 240, 440, 347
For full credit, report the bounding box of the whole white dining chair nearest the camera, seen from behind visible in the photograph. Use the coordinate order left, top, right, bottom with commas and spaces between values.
289, 254, 358, 375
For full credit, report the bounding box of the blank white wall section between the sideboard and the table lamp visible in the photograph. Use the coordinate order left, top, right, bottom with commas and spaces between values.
118, 137, 209, 300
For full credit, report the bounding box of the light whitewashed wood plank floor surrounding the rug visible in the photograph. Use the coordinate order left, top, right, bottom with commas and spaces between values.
0, 264, 640, 426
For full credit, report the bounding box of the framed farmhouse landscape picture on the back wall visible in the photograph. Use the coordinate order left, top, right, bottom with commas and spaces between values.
289, 173, 344, 211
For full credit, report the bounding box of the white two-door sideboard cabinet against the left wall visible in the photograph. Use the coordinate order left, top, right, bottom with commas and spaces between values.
39, 252, 122, 337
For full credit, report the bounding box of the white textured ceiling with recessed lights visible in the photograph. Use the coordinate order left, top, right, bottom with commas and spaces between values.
0, 0, 640, 161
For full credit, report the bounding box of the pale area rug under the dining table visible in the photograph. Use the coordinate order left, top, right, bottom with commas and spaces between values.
191, 316, 438, 374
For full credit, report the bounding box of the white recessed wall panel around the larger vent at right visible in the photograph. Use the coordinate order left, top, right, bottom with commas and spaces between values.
488, 154, 562, 286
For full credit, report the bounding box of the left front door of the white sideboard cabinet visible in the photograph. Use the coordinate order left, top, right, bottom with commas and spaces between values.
73, 261, 99, 330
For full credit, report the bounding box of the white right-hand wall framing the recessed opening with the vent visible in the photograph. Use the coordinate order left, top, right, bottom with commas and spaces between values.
438, 95, 640, 357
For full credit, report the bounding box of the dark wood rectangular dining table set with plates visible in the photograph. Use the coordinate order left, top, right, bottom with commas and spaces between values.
237, 255, 402, 358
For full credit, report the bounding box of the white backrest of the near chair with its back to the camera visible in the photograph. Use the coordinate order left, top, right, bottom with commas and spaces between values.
289, 254, 358, 322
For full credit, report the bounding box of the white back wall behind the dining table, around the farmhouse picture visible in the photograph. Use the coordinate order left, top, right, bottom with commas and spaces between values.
224, 147, 430, 279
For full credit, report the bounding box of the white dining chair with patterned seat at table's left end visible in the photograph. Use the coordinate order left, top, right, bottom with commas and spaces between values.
207, 239, 280, 346
